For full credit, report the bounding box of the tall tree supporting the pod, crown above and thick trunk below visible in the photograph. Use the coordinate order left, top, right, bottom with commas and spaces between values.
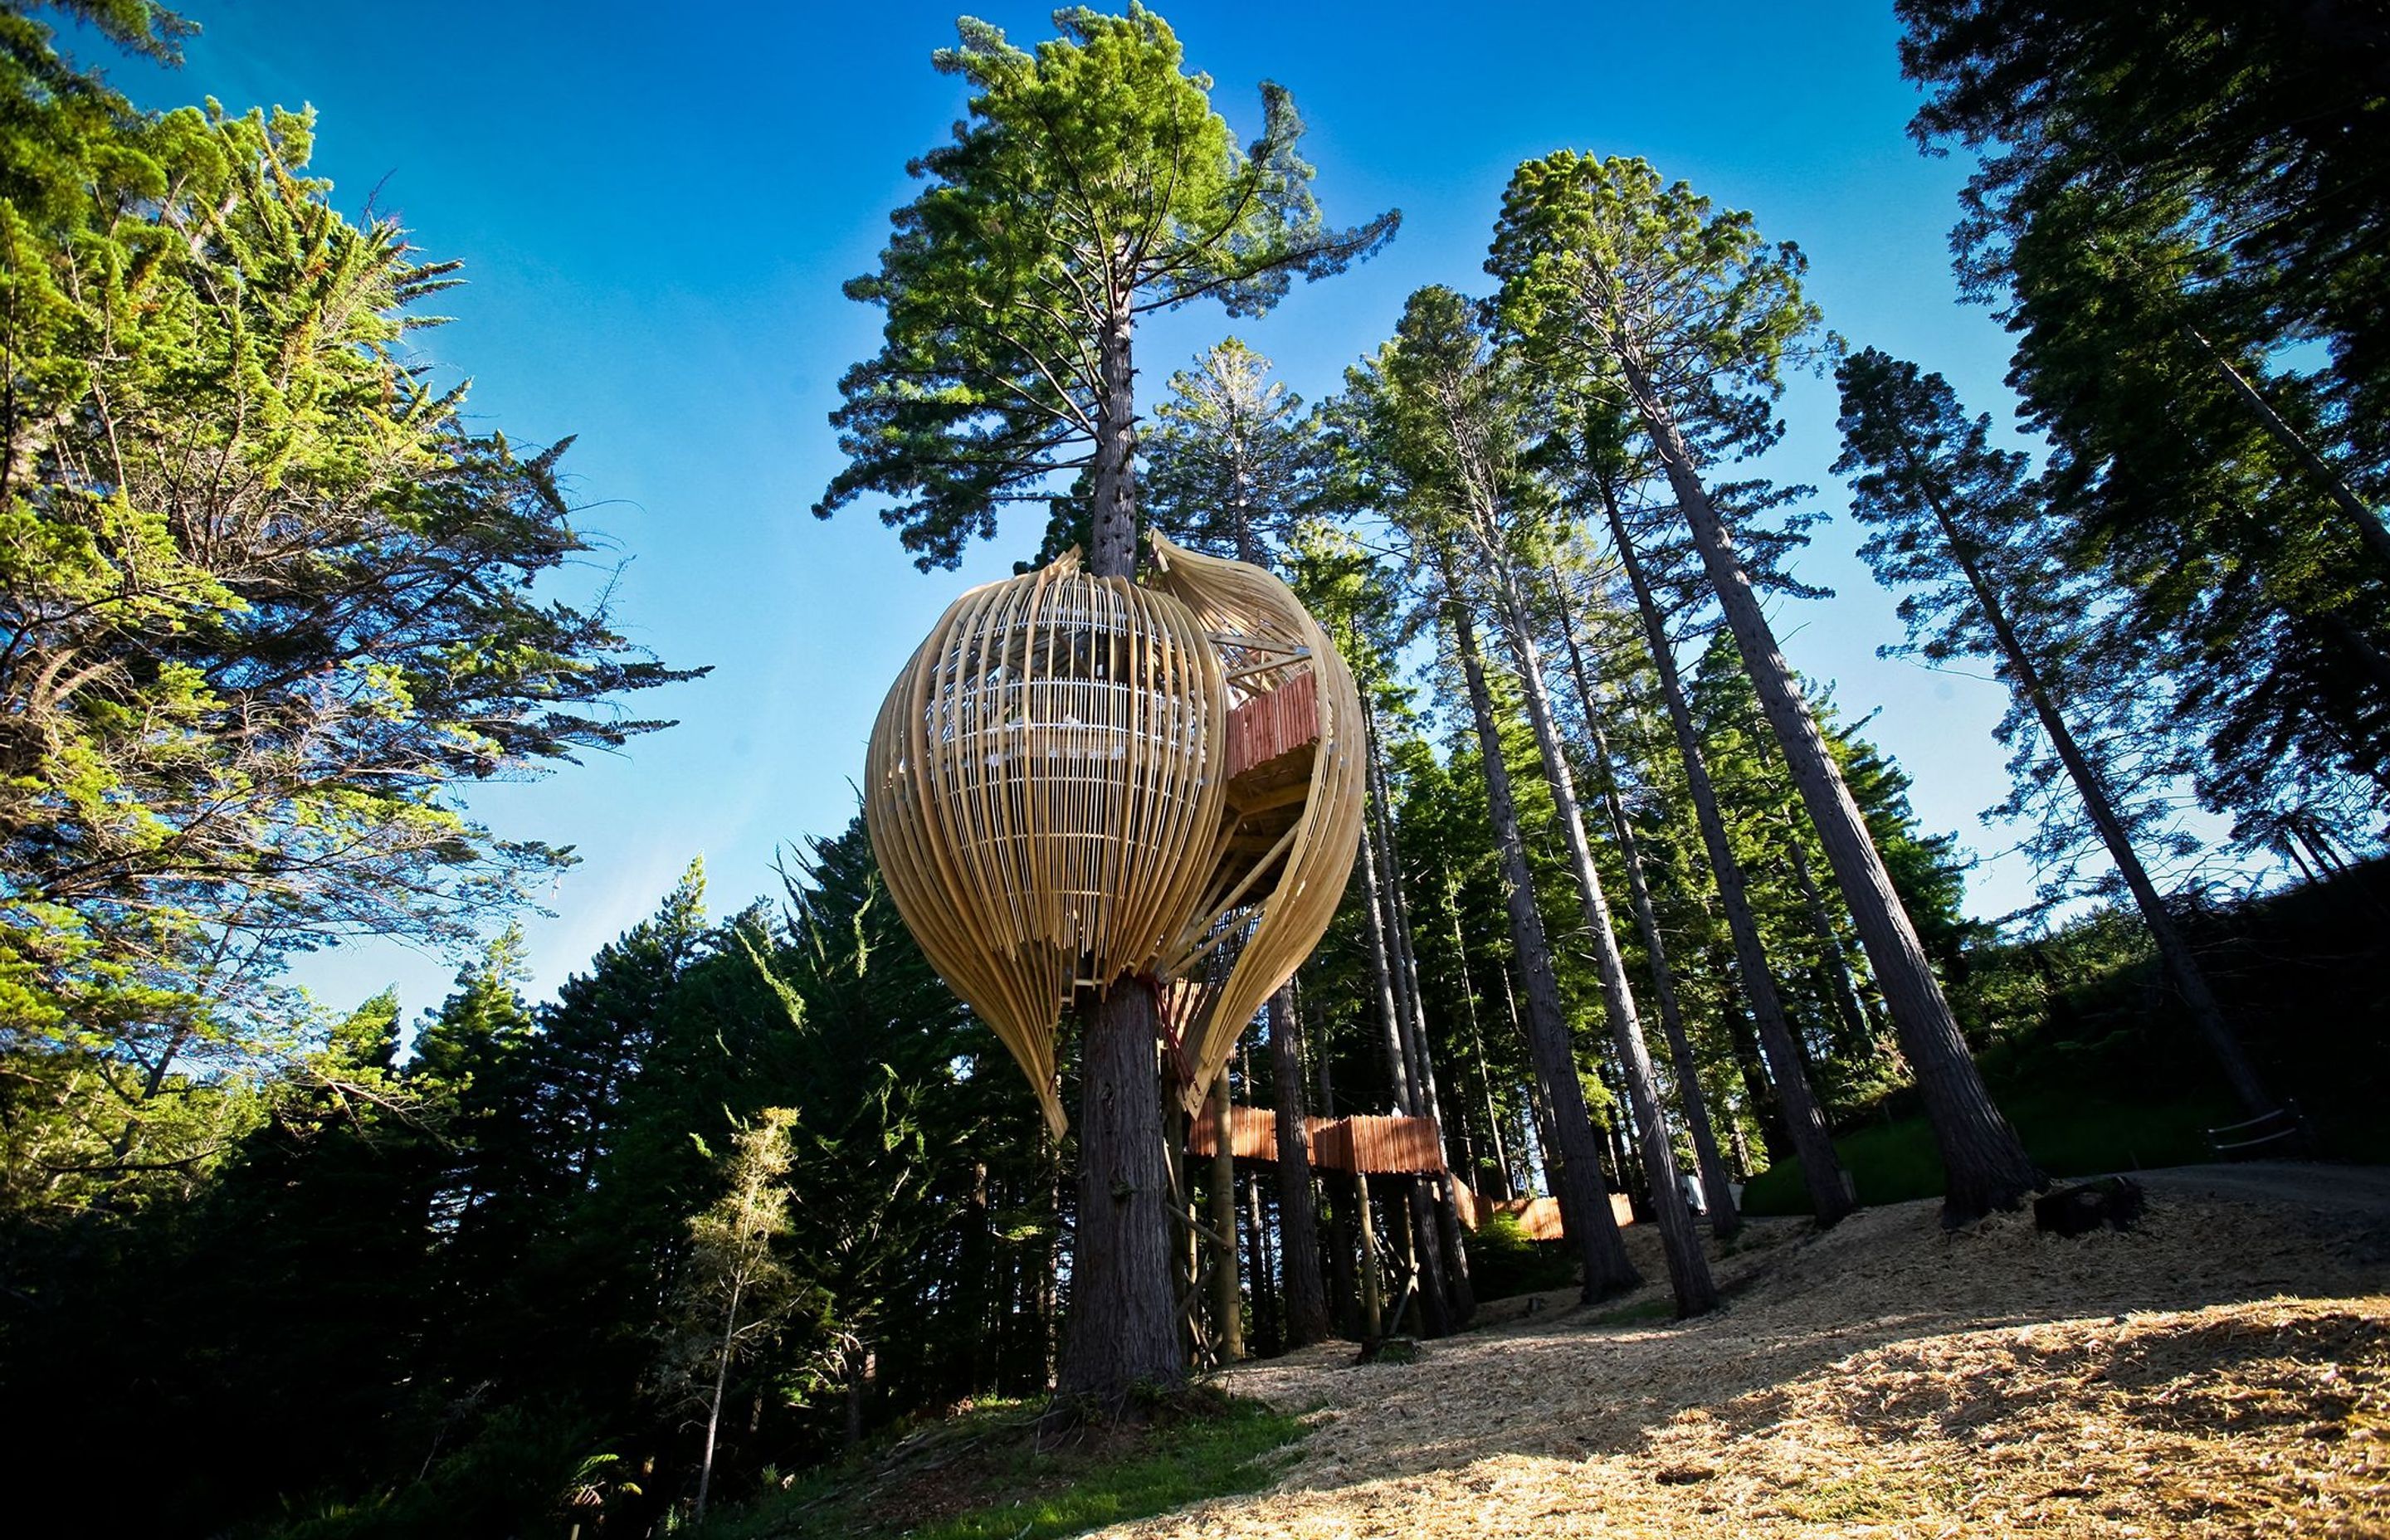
815, 5, 1398, 1396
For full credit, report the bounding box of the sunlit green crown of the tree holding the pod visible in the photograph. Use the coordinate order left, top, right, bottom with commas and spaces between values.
812, 5, 1398, 572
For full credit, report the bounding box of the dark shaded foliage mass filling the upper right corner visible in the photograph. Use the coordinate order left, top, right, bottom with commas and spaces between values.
1898, 0, 2390, 846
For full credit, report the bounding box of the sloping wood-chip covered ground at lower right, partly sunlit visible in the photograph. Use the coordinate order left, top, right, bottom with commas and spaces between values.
1105, 1165, 2390, 1540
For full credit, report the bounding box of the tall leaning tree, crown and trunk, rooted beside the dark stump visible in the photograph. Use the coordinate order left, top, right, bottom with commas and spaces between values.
1489, 151, 2041, 1225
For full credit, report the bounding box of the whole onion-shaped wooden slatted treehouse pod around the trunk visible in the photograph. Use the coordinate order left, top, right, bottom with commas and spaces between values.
863, 536, 1364, 1133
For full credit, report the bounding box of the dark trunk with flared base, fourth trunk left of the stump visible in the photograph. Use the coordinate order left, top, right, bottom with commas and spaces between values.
1444, 583, 1642, 1304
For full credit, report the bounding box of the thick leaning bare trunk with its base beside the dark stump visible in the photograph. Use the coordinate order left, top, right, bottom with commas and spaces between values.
1623, 356, 2043, 1225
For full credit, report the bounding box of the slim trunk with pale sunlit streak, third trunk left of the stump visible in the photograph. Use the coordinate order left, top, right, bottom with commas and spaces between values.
1491, 555, 1719, 1315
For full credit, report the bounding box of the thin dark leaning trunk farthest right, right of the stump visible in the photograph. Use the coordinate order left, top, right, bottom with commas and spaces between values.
1912, 456, 2275, 1117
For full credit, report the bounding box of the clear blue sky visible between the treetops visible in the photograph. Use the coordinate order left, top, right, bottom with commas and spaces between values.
112, 0, 2065, 1014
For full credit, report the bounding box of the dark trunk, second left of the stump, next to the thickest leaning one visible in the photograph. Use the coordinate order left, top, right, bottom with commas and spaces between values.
1602, 483, 1852, 1226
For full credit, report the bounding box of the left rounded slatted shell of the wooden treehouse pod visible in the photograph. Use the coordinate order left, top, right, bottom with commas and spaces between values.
863, 555, 1228, 1133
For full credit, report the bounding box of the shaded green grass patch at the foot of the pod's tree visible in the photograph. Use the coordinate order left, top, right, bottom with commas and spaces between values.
705, 1387, 1303, 1540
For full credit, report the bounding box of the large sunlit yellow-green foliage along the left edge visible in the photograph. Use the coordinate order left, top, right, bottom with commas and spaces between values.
0, 12, 690, 1207
